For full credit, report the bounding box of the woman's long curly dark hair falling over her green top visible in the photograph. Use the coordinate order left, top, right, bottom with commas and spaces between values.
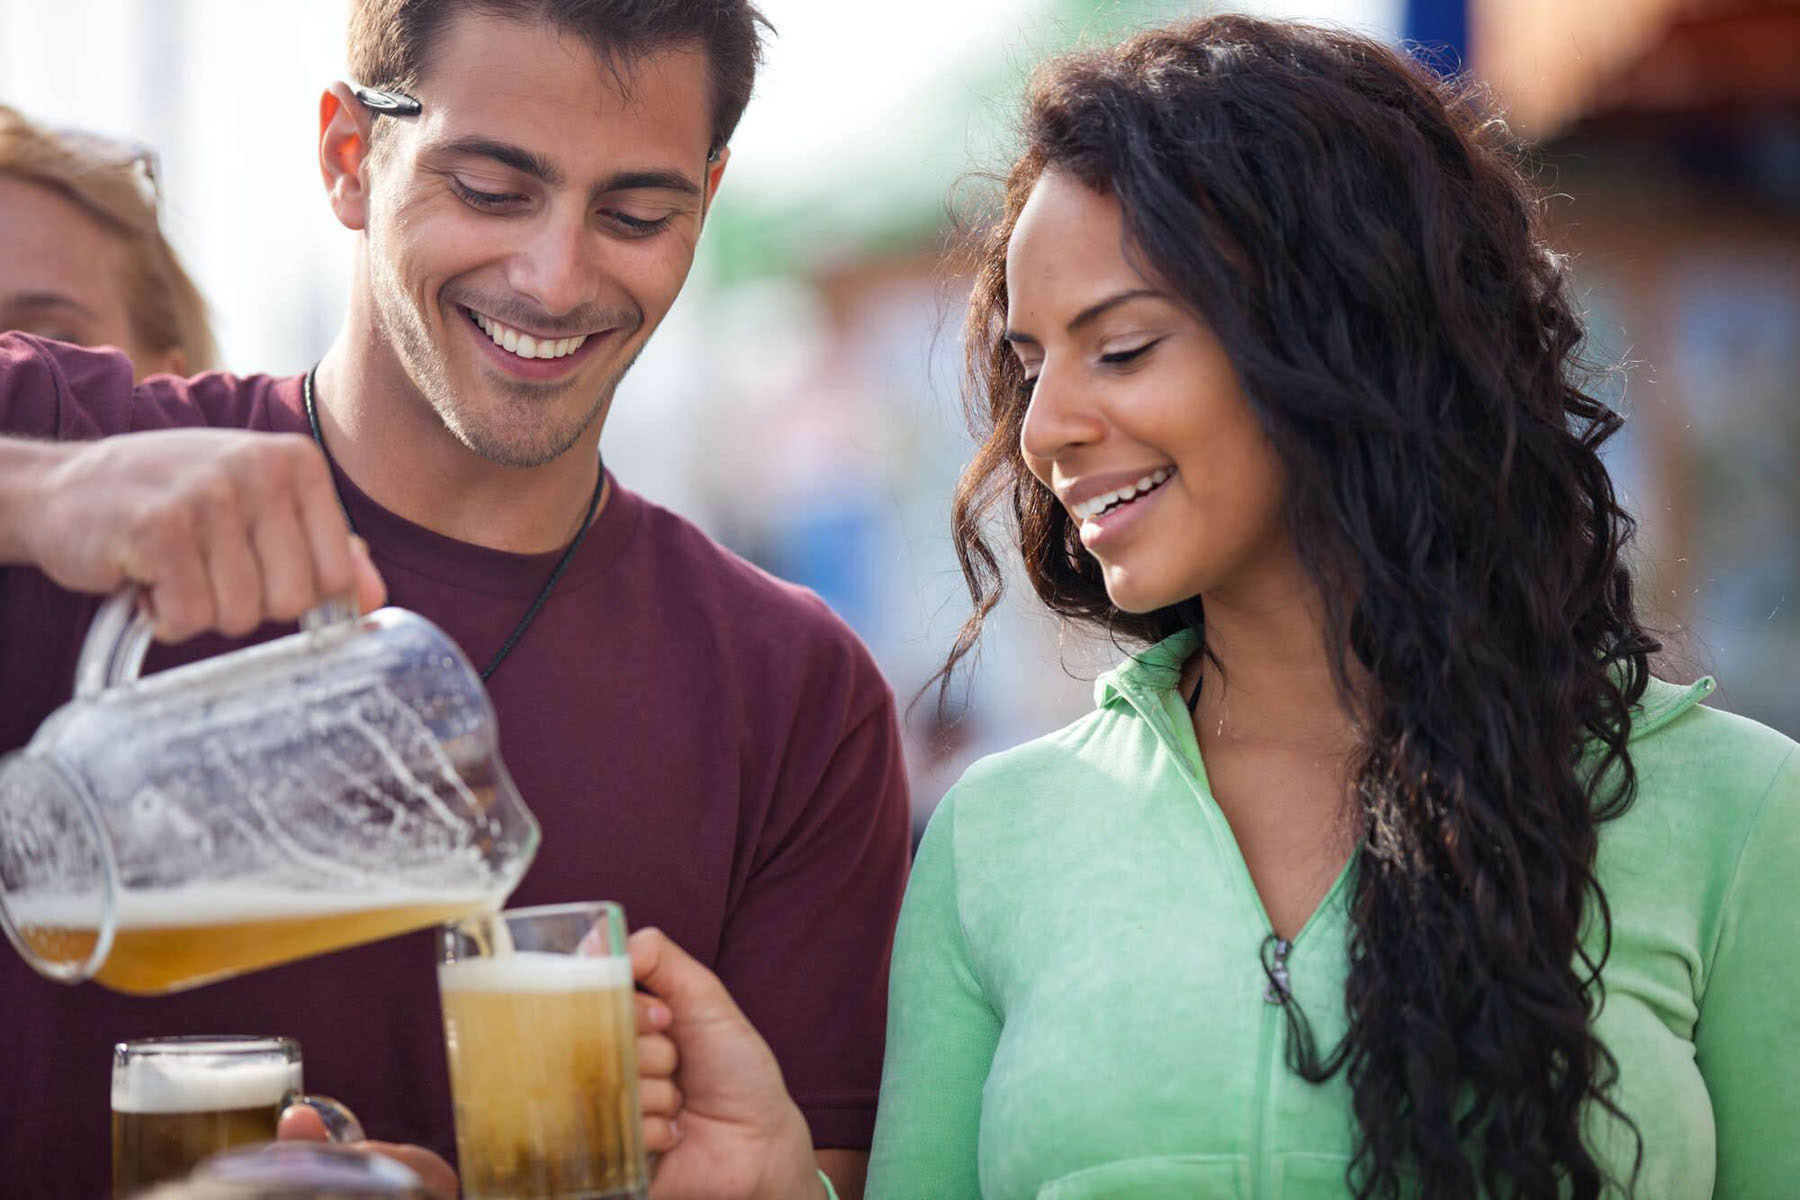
943, 16, 1660, 1200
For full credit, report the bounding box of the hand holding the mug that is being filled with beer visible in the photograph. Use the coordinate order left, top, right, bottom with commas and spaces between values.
630, 928, 824, 1200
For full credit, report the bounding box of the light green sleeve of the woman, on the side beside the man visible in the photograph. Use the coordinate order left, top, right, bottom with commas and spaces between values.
866, 788, 1001, 1200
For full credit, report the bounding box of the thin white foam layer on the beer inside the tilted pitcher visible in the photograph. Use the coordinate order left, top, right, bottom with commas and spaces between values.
7, 883, 502, 930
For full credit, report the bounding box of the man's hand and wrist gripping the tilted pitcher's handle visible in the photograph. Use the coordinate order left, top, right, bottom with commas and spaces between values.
0, 430, 385, 642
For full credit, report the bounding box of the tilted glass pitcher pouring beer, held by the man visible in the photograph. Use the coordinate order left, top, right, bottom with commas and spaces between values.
0, 594, 538, 995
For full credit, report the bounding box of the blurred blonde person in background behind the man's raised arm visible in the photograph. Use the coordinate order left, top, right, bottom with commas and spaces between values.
0, 104, 216, 378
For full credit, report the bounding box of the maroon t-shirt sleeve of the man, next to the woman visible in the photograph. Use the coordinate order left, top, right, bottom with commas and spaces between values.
716, 648, 911, 1150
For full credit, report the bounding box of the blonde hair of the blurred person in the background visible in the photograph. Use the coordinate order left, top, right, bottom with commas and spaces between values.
0, 104, 218, 374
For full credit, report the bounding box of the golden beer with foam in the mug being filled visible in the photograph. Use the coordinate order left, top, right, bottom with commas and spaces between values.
437, 950, 648, 1200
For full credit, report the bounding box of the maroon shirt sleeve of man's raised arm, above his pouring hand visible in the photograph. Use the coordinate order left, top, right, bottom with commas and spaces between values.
0, 333, 304, 441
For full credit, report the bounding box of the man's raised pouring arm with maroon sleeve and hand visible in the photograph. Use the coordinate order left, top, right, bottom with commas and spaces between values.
0, 333, 383, 642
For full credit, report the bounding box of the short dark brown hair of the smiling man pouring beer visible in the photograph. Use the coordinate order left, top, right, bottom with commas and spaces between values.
349, 0, 774, 151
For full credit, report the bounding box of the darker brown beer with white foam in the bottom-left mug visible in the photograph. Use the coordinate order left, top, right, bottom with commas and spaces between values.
112, 1038, 301, 1200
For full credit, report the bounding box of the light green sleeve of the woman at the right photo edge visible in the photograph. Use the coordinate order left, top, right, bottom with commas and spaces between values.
1694, 750, 1800, 1196
